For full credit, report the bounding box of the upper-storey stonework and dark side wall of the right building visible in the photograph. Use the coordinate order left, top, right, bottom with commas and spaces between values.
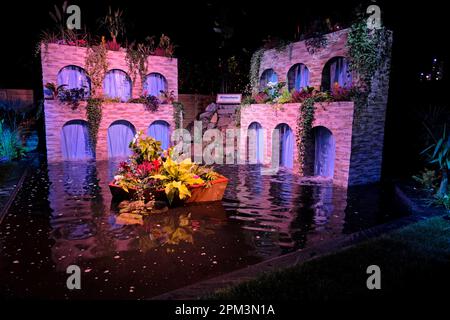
255, 29, 392, 185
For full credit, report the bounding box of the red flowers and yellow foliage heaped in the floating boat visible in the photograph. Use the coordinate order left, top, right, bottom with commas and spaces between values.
110, 132, 228, 204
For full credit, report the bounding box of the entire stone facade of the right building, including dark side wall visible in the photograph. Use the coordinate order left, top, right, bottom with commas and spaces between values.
241, 29, 392, 186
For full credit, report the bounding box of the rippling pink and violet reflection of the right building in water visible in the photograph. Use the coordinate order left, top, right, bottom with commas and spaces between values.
230, 166, 347, 257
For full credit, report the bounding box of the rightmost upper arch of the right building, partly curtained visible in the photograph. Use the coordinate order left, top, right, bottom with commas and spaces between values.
322, 57, 352, 91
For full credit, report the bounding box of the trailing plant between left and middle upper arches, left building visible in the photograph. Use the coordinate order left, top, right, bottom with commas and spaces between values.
85, 37, 108, 97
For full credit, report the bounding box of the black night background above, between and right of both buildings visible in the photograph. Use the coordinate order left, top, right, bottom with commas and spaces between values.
0, 0, 450, 177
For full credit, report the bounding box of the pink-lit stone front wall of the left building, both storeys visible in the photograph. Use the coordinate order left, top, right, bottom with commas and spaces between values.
41, 44, 178, 162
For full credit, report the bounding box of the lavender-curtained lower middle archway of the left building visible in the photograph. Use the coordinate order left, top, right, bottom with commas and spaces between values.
108, 120, 136, 158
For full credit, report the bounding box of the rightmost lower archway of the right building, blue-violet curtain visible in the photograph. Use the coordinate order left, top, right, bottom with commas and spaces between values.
313, 127, 336, 178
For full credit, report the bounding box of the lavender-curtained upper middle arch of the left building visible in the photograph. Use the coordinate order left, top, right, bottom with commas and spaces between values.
103, 69, 131, 102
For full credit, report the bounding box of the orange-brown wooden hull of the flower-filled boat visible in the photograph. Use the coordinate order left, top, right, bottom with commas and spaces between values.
109, 176, 228, 204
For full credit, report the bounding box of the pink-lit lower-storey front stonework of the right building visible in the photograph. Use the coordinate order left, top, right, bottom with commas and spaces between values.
240, 102, 354, 187
